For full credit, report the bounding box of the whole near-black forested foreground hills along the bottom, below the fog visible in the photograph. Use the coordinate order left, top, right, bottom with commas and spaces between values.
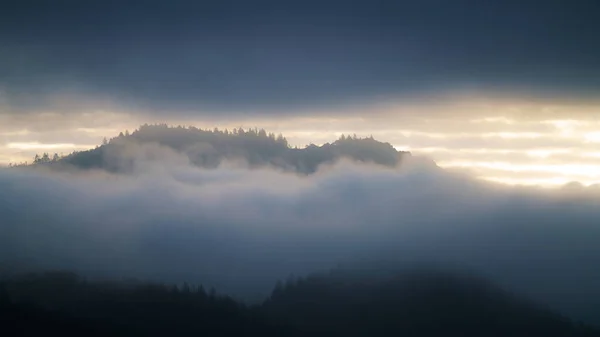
0, 270, 600, 336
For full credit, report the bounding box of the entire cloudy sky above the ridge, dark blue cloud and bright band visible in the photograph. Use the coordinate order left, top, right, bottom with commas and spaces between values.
0, 0, 600, 186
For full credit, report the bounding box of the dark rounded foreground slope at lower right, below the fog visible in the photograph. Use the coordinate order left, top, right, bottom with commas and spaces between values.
263, 271, 598, 336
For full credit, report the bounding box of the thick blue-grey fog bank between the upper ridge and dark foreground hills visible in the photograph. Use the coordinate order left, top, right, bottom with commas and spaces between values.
0, 145, 600, 323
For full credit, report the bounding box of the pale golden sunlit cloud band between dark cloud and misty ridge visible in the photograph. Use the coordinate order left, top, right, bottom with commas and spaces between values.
0, 96, 600, 185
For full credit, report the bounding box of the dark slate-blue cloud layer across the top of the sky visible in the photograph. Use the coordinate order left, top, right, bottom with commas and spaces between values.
0, 0, 600, 111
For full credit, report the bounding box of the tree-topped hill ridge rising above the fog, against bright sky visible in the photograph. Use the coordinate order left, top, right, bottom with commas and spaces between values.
36, 124, 410, 174
